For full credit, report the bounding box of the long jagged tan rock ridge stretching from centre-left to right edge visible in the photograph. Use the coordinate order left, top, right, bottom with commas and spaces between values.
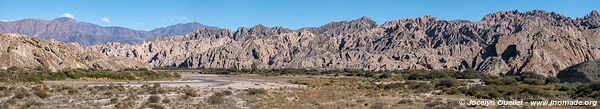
91, 10, 600, 75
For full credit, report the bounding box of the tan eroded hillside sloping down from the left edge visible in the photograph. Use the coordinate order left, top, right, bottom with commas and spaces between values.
0, 33, 148, 70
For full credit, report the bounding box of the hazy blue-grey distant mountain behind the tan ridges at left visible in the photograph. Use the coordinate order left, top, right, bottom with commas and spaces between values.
0, 17, 216, 45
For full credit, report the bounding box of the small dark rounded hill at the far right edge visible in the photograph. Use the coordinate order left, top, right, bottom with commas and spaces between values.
556, 60, 600, 83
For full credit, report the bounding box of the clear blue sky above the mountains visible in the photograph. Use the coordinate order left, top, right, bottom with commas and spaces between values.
0, 0, 600, 30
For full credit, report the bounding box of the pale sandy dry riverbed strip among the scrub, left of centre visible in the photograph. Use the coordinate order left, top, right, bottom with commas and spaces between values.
45, 73, 304, 89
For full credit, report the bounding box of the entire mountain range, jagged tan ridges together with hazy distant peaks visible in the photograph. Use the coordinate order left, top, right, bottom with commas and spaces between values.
0, 10, 600, 77
